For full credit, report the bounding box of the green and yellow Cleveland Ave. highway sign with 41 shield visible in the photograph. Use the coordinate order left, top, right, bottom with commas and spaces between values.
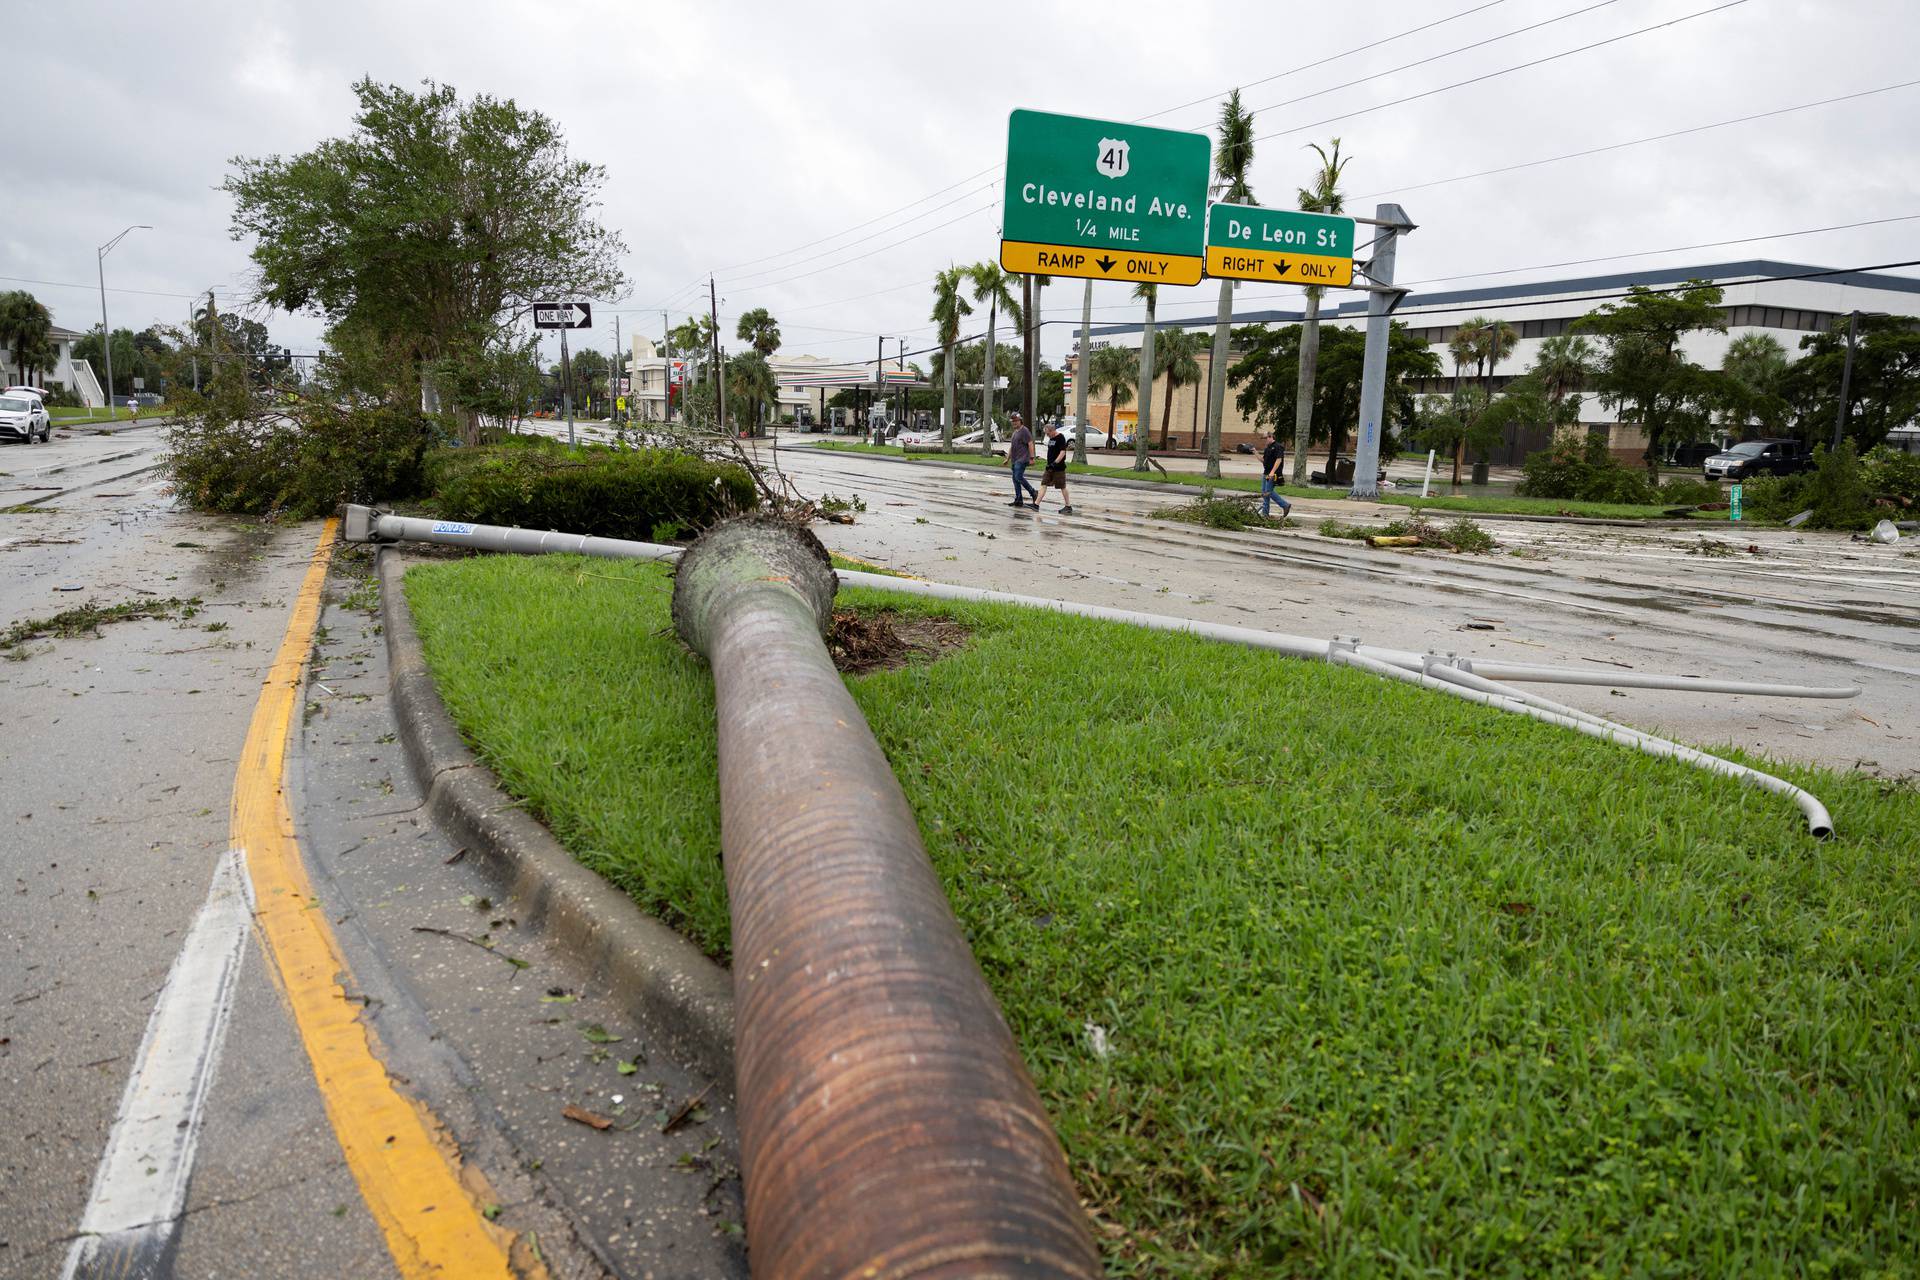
1000, 111, 1213, 284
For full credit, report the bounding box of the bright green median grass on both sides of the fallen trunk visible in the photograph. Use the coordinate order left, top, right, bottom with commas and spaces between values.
407, 557, 1920, 1276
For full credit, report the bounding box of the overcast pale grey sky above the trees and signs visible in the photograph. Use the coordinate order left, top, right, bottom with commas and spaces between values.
0, 0, 1920, 370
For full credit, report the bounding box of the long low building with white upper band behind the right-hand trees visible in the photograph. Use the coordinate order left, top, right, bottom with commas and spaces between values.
1068, 259, 1920, 466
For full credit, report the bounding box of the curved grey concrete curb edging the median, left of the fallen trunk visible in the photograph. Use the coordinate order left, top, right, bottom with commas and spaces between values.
380, 547, 733, 1092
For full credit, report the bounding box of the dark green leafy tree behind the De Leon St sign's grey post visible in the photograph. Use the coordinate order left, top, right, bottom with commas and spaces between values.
1227, 320, 1440, 466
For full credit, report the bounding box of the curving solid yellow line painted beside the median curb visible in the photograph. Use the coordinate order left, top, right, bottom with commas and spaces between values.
232, 520, 515, 1280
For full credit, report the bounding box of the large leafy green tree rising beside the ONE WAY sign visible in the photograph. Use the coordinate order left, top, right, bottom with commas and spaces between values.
225, 79, 624, 435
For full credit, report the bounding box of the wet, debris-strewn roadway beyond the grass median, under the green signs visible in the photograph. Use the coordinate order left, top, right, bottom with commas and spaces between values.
778, 438, 1920, 775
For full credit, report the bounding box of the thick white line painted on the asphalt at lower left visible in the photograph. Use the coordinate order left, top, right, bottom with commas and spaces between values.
60, 850, 253, 1280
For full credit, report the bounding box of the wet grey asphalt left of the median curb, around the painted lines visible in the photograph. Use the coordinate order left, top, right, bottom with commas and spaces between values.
0, 428, 745, 1278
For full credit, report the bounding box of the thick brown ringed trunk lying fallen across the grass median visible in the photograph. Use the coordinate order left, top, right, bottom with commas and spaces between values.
674, 518, 1100, 1280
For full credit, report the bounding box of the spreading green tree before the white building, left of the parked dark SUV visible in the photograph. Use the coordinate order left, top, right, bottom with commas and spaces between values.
1572, 280, 1726, 480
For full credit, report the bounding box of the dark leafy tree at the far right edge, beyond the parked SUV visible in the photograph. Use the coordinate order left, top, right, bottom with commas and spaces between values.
1780, 315, 1920, 453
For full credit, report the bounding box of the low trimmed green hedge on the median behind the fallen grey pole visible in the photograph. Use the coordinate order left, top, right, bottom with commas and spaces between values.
426, 443, 760, 541
